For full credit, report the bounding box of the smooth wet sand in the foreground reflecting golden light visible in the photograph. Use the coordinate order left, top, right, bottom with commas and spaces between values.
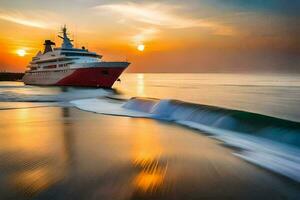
0, 107, 300, 200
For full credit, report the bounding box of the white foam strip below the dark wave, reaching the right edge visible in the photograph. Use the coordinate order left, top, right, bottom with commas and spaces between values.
177, 121, 300, 182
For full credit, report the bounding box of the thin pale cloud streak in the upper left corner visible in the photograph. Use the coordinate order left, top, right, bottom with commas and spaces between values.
0, 10, 58, 29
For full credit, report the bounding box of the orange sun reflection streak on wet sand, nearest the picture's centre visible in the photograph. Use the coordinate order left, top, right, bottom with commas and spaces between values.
132, 119, 168, 194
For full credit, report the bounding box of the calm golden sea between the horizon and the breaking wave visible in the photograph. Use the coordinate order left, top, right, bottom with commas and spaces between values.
0, 73, 300, 122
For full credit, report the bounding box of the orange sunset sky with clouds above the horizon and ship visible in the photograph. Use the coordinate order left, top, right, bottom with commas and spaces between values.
0, 0, 300, 72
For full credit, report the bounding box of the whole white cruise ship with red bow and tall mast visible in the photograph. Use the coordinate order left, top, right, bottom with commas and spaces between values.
23, 26, 130, 88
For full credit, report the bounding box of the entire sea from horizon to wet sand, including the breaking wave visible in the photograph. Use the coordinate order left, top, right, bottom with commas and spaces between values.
0, 73, 300, 200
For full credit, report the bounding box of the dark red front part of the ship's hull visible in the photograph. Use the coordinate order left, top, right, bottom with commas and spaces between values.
54, 67, 125, 88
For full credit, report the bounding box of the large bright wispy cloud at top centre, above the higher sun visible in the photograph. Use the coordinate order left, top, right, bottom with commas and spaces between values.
94, 3, 234, 35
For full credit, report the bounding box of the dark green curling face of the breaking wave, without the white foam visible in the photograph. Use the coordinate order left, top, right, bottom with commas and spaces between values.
122, 98, 300, 147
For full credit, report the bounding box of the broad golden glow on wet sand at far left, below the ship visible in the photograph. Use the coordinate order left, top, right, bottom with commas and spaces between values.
0, 108, 68, 199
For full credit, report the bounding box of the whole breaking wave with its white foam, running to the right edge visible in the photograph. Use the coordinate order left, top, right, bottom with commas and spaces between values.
71, 98, 300, 182
